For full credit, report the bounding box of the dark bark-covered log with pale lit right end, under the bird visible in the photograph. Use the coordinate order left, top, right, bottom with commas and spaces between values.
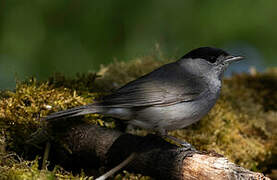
42, 124, 269, 180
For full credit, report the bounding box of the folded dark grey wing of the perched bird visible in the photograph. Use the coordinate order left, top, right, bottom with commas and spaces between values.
101, 62, 206, 108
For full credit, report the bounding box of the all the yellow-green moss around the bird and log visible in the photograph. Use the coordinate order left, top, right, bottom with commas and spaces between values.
0, 56, 277, 179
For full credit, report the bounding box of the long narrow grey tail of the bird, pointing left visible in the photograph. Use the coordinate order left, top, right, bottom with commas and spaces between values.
42, 104, 101, 121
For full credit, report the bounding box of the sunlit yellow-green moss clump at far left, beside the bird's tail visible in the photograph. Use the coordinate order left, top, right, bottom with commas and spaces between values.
0, 78, 102, 150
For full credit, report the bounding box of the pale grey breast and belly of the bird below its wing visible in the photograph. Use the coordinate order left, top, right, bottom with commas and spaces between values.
132, 89, 220, 130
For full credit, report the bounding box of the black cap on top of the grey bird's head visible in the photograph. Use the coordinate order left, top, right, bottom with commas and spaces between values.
182, 47, 229, 63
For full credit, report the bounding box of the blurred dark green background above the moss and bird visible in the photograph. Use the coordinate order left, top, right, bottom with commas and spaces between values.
0, 0, 277, 89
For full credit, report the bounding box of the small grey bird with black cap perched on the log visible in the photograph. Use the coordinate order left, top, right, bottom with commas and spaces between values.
44, 47, 244, 148
